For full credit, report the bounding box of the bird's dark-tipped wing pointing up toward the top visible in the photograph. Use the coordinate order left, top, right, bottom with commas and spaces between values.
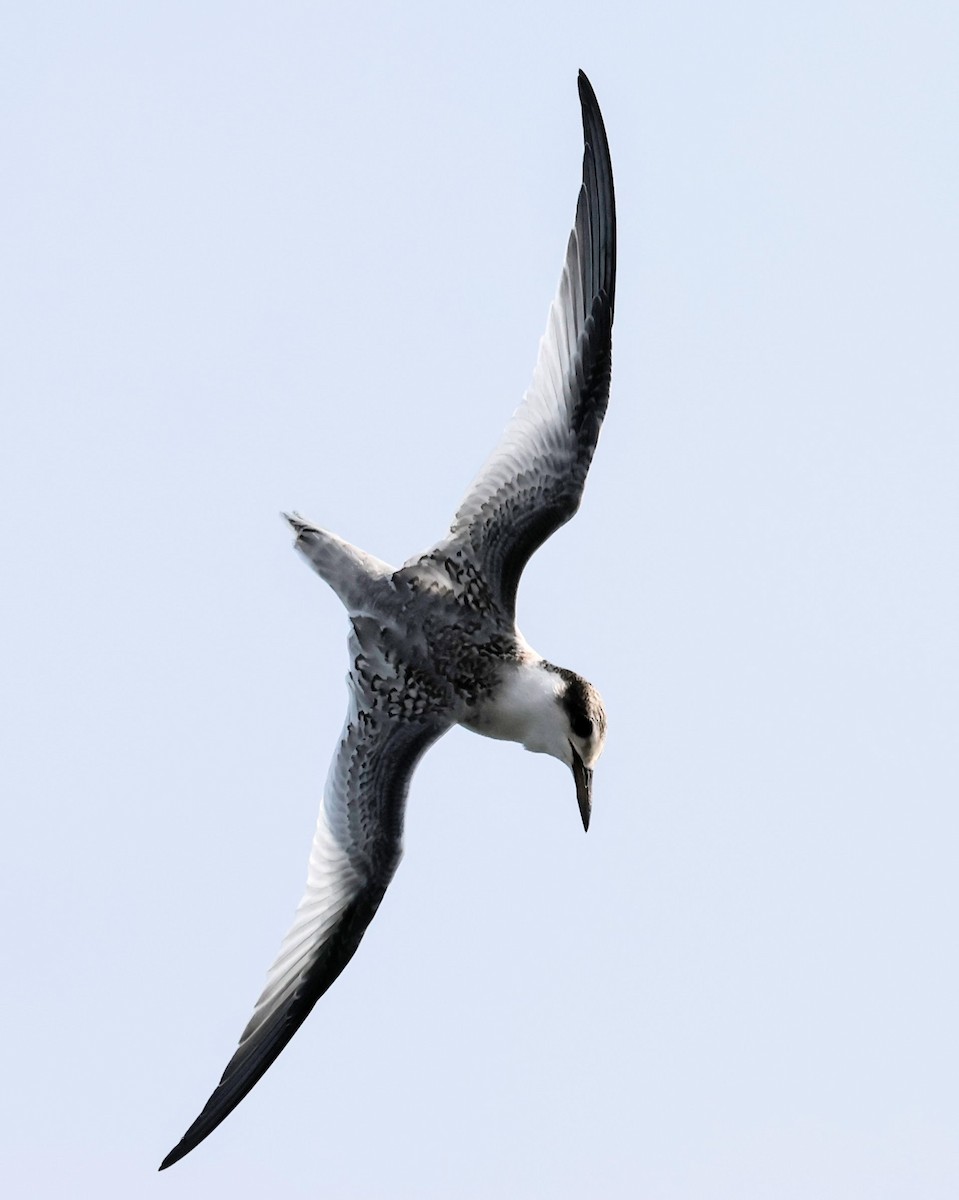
425, 72, 616, 617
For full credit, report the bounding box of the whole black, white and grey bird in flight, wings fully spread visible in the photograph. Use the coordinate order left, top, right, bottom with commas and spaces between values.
160, 72, 616, 1170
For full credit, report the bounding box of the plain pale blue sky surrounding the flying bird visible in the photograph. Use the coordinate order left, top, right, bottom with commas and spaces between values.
0, 0, 959, 1200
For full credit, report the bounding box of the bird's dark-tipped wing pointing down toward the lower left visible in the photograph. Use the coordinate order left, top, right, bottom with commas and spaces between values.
160, 638, 450, 1170
